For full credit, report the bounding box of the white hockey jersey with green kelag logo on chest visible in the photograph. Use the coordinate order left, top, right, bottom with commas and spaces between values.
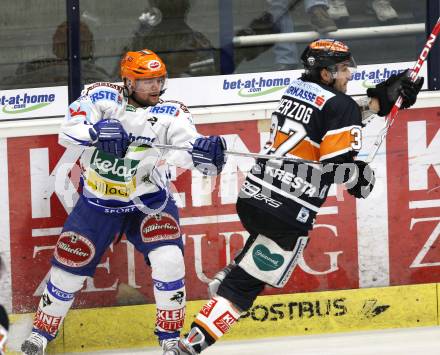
59, 83, 200, 213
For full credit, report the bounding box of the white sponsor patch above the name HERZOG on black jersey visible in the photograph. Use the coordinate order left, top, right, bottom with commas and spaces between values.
285, 80, 335, 110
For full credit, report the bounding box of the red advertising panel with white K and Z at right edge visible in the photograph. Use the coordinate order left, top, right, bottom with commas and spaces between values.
387, 108, 440, 285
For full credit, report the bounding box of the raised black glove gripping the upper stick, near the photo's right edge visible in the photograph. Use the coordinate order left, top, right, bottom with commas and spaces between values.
367, 69, 424, 116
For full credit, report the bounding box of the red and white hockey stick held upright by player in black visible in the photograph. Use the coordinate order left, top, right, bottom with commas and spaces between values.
365, 17, 440, 163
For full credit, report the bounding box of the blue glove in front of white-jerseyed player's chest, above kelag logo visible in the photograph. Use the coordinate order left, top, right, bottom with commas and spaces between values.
89, 118, 130, 158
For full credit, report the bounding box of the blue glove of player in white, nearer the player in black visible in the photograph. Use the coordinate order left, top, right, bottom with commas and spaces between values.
191, 136, 226, 176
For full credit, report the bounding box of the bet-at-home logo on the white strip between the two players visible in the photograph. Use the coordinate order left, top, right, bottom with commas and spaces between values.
223, 76, 290, 97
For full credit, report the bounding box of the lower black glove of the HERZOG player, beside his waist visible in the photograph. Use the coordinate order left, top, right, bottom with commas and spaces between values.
345, 160, 376, 198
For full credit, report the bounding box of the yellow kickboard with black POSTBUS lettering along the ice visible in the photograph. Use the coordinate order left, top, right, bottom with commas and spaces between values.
7, 284, 440, 354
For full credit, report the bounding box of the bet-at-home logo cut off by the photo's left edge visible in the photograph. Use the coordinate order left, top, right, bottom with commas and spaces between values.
0, 92, 55, 115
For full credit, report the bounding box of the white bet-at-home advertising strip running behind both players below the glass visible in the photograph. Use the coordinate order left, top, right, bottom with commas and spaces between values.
0, 62, 428, 122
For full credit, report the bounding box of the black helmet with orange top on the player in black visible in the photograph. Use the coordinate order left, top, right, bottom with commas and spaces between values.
301, 39, 356, 70
